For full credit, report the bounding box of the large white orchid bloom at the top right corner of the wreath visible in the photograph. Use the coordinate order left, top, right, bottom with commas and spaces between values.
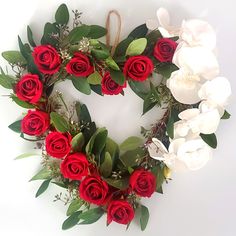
180, 19, 216, 50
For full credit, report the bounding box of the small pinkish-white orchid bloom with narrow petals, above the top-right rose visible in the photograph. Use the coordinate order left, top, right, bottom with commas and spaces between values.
146, 7, 179, 38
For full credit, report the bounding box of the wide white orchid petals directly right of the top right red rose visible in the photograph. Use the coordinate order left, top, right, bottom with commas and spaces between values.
172, 43, 219, 80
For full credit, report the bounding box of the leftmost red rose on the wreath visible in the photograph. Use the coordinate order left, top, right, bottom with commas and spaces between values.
16, 74, 43, 104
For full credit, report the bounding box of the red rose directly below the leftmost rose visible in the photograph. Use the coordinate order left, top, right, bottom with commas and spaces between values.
21, 110, 50, 136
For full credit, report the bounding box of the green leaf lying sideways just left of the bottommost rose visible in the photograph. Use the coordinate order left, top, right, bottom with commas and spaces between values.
79, 207, 104, 224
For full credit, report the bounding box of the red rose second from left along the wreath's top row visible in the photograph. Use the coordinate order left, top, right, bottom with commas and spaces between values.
66, 52, 94, 77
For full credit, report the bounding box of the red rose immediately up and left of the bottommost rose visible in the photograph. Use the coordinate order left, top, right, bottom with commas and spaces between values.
79, 176, 109, 205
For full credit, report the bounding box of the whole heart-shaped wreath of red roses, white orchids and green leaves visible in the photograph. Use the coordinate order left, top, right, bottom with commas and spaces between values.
0, 4, 231, 230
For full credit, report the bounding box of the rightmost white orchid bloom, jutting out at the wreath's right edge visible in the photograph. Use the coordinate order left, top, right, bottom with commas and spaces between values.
198, 77, 231, 106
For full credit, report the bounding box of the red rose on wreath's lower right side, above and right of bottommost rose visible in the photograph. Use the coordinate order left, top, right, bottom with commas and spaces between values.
129, 170, 156, 197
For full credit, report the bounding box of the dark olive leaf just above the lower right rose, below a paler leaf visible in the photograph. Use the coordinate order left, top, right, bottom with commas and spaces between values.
120, 147, 145, 167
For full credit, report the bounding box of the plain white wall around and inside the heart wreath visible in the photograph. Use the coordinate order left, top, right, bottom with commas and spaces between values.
0, 0, 236, 236
